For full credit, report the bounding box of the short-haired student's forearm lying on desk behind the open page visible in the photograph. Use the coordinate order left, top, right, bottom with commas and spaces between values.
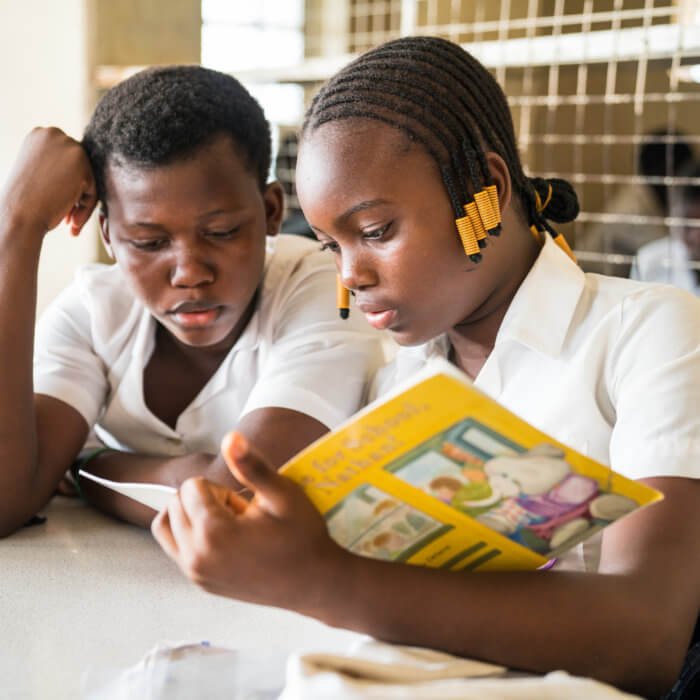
80, 450, 241, 527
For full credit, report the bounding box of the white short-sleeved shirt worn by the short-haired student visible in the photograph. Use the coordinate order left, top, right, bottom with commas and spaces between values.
34, 235, 380, 456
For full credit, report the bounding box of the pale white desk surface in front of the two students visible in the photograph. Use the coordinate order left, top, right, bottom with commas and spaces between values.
0, 497, 358, 700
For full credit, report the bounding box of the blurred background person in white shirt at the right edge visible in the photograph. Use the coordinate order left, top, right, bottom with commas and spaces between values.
630, 162, 700, 296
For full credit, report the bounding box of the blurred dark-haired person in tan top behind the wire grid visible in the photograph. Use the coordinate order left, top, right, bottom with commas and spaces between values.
577, 129, 693, 277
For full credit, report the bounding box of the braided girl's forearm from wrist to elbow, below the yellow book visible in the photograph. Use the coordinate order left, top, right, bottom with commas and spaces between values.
308, 555, 691, 694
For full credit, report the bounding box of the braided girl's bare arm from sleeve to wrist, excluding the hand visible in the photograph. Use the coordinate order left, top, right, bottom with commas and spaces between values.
312, 478, 700, 695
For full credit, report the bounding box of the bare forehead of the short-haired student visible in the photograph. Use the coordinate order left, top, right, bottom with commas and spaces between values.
105, 134, 262, 215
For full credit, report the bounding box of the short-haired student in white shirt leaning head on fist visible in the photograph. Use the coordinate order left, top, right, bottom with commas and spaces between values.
0, 66, 379, 535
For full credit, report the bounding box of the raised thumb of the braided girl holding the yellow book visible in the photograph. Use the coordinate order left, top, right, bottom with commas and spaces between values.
221, 431, 297, 518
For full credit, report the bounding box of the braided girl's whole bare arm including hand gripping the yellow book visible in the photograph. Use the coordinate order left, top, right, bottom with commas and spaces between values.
152, 438, 700, 696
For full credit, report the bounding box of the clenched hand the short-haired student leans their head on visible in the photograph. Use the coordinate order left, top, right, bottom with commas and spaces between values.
0, 127, 97, 236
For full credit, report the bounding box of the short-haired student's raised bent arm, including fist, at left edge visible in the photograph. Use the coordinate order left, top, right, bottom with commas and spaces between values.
0, 129, 95, 536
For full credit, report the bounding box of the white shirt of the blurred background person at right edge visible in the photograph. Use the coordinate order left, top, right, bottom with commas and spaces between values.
630, 231, 700, 296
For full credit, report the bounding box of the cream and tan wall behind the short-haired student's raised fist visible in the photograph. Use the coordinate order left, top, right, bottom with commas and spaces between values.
0, 0, 201, 311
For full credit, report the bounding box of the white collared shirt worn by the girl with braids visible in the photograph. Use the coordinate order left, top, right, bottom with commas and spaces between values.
373, 236, 700, 569
